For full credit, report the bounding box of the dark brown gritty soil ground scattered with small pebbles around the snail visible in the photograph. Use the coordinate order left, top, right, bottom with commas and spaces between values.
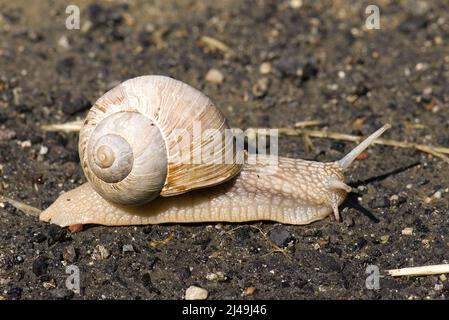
0, 0, 449, 299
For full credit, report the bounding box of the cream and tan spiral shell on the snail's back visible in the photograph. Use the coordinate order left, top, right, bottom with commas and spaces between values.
79, 76, 242, 205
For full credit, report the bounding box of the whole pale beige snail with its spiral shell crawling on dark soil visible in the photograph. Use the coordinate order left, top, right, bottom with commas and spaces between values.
40, 76, 389, 226
